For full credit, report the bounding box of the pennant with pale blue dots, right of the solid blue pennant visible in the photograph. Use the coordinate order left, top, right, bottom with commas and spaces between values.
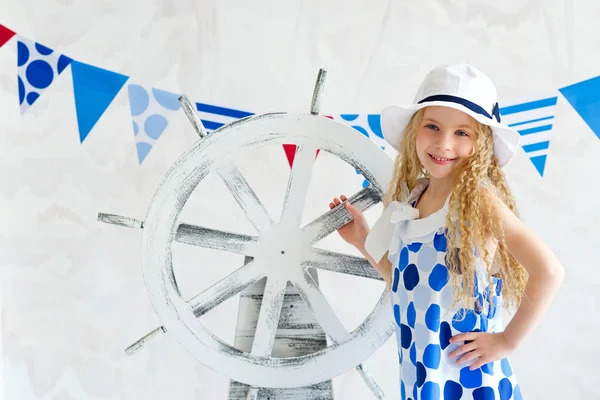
127, 83, 181, 165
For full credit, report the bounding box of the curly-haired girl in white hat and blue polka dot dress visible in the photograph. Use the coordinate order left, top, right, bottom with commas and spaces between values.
329, 64, 563, 400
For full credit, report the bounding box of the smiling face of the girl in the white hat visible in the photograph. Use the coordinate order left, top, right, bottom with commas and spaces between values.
416, 106, 477, 179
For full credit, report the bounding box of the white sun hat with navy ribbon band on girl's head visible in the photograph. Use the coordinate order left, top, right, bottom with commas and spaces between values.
381, 64, 521, 167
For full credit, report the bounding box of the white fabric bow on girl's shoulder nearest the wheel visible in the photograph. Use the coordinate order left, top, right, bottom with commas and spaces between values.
365, 196, 419, 263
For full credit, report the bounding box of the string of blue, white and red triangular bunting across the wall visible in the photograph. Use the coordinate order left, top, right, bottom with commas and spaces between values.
0, 21, 600, 178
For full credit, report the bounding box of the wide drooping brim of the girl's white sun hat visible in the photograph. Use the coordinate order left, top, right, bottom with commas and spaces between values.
380, 101, 521, 167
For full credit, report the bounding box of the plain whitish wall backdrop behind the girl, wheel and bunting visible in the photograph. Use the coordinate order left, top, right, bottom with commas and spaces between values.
0, 0, 600, 400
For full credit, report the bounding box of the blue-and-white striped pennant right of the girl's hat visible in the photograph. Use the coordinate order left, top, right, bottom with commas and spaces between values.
500, 93, 558, 176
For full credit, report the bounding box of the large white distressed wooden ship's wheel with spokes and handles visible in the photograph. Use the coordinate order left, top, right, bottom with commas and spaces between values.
99, 71, 393, 397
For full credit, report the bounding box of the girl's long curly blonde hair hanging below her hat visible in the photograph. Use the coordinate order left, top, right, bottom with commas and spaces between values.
383, 108, 527, 309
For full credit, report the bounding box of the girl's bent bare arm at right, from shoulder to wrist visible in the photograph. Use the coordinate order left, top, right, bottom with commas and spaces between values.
481, 189, 564, 349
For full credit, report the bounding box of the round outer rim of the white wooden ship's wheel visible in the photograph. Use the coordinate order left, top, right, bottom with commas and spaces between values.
142, 113, 393, 387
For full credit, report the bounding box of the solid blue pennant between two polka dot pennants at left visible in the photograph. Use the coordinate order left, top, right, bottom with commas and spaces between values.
71, 61, 129, 143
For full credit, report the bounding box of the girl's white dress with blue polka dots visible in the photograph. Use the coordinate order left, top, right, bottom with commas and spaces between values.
367, 178, 522, 400
